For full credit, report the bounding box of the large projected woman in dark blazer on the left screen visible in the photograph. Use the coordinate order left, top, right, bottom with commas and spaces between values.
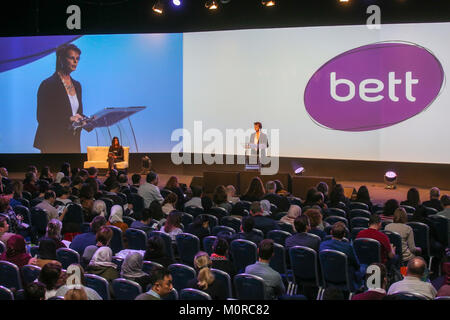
34, 44, 84, 153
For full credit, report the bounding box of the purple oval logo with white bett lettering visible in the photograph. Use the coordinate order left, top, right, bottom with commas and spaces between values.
304, 42, 444, 131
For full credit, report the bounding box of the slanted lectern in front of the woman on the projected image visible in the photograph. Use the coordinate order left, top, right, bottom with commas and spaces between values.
73, 106, 146, 152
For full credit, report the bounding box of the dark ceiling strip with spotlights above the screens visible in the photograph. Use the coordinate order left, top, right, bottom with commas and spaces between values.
0, 0, 450, 36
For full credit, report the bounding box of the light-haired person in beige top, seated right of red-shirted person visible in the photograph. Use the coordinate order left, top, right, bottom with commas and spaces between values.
384, 208, 421, 262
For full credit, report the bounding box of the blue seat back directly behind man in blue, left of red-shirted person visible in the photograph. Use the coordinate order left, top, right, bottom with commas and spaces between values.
319, 249, 352, 292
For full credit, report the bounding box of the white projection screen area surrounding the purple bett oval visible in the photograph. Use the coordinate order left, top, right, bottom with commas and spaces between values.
183, 23, 450, 163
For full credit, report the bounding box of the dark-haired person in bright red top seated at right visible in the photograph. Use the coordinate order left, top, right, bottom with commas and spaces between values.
356, 213, 400, 269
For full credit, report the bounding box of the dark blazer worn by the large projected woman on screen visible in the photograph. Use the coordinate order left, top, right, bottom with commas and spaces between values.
33, 72, 83, 153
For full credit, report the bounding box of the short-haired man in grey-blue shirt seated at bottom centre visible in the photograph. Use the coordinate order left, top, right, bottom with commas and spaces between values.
245, 239, 285, 300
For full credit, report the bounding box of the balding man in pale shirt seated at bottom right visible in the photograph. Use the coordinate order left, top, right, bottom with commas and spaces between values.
388, 257, 437, 299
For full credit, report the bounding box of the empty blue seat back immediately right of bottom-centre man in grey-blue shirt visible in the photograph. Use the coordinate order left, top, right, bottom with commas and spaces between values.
289, 246, 320, 287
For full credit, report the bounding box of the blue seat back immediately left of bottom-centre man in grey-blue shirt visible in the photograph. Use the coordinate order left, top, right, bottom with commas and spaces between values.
234, 273, 266, 300
